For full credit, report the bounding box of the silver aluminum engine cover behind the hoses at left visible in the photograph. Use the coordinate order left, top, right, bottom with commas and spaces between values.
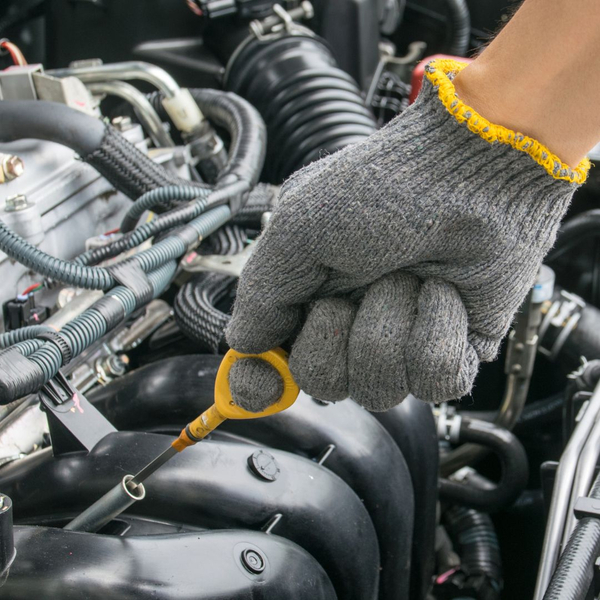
0, 125, 189, 328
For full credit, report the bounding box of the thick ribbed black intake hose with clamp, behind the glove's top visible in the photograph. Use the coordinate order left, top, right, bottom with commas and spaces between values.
225, 35, 376, 183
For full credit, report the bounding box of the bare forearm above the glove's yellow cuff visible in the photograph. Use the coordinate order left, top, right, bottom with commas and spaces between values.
455, 0, 600, 165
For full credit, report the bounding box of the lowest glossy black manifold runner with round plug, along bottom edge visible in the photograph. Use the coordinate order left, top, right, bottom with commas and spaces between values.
0, 527, 336, 600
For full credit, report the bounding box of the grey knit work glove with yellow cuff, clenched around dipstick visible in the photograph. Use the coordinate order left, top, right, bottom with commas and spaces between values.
226, 60, 589, 410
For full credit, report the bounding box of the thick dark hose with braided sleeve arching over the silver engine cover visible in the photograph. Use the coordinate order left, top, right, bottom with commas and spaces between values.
0, 100, 206, 199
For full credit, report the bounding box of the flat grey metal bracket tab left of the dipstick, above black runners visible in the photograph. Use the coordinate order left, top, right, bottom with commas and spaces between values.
39, 371, 117, 456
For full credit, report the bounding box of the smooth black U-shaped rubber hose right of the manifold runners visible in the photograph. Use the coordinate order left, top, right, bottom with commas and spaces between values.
440, 419, 529, 512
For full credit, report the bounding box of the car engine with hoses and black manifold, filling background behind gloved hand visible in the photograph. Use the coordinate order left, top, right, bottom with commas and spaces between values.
0, 0, 600, 600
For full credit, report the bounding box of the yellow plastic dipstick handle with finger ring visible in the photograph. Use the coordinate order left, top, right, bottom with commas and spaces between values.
171, 348, 300, 452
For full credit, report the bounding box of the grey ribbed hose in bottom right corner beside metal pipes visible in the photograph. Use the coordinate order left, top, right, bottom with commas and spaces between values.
544, 475, 600, 600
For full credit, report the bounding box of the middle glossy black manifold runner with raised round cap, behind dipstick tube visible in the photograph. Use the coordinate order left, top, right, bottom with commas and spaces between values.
0, 432, 380, 600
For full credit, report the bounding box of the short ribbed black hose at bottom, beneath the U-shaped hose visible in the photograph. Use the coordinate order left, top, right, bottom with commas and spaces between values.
444, 506, 503, 600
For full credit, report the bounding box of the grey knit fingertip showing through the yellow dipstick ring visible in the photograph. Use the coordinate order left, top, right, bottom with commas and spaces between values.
229, 358, 283, 412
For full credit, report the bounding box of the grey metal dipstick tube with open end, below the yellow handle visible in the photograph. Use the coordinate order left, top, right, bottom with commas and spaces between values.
64, 475, 146, 533
